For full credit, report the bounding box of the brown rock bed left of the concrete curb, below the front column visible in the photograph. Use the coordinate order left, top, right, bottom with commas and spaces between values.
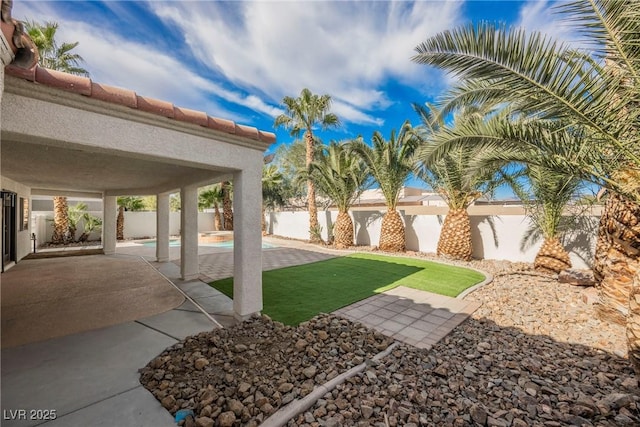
140, 315, 393, 426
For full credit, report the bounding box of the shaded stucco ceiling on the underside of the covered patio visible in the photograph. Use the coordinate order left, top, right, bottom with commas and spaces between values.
1, 135, 231, 197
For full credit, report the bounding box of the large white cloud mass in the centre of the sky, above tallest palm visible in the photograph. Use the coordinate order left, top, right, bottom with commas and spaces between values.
150, 1, 461, 124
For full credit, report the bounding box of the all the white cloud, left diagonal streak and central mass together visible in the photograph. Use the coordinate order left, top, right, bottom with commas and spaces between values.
14, 0, 462, 125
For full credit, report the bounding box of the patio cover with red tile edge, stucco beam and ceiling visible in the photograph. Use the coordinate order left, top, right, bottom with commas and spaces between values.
0, 67, 275, 197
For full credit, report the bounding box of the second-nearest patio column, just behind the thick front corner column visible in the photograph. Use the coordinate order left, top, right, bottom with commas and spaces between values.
180, 186, 200, 280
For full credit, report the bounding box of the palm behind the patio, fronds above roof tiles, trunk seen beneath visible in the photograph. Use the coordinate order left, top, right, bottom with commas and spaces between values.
25, 21, 89, 243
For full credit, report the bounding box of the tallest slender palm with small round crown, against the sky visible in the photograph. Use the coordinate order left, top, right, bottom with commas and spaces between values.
274, 88, 340, 242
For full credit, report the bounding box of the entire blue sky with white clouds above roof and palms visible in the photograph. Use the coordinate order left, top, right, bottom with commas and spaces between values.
13, 0, 575, 199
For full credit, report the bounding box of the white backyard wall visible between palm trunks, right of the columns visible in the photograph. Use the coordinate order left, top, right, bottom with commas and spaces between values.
267, 209, 599, 268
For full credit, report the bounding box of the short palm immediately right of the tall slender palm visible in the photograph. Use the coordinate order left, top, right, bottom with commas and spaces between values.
308, 142, 369, 248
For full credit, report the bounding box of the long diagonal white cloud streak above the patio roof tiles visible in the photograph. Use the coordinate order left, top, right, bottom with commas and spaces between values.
9, 2, 280, 123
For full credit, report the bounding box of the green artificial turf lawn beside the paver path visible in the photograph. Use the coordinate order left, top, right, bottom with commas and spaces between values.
210, 254, 485, 325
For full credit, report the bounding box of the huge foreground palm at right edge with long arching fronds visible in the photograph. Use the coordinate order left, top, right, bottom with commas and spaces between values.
413, 0, 640, 372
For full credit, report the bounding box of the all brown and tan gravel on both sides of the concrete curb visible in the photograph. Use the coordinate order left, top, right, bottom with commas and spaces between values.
141, 254, 640, 427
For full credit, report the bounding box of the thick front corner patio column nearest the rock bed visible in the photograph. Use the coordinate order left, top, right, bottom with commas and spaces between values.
233, 160, 263, 320
